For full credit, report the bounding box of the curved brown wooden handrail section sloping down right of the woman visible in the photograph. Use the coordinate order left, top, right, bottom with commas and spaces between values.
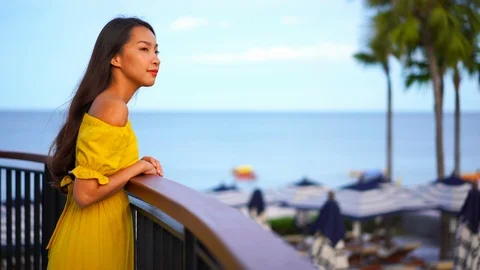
126, 176, 312, 269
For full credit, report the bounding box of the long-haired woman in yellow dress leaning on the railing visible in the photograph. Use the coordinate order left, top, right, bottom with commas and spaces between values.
47, 18, 163, 269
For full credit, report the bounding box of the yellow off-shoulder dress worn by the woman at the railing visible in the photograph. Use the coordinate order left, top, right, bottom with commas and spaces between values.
44, 113, 139, 270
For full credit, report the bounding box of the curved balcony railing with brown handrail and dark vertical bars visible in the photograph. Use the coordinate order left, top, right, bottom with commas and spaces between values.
0, 151, 312, 270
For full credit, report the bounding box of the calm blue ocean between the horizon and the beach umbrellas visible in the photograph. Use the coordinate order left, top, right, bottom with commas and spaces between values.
0, 111, 480, 191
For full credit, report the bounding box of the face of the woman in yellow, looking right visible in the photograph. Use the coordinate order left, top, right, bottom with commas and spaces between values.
112, 26, 160, 86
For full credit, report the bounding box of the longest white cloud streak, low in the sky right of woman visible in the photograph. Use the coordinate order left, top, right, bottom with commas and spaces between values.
192, 43, 355, 63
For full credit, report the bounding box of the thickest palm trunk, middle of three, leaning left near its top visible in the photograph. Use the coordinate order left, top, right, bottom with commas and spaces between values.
424, 42, 449, 260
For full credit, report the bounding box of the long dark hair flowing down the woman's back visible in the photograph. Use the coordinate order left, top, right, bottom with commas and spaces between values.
48, 17, 155, 188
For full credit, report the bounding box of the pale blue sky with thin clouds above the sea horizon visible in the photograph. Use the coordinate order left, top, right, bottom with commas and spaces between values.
0, 0, 480, 112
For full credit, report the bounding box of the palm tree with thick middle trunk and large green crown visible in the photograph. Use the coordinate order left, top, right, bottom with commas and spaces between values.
368, 0, 478, 259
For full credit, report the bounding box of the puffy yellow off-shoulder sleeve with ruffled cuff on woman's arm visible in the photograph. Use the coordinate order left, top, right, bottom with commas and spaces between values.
60, 114, 131, 186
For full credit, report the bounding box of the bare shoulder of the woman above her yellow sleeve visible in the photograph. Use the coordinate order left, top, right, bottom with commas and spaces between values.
88, 95, 128, 127
